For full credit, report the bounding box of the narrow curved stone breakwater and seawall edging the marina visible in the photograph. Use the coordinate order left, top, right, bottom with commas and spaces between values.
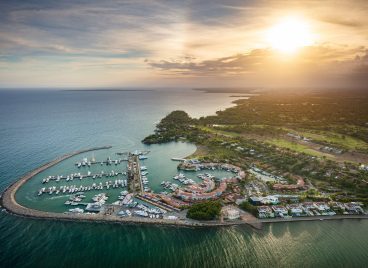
0, 145, 368, 230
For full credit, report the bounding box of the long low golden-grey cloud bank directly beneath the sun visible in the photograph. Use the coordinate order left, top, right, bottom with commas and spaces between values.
146, 46, 366, 75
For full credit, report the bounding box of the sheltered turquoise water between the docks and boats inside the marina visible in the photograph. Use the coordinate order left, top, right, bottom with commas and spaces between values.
16, 142, 233, 212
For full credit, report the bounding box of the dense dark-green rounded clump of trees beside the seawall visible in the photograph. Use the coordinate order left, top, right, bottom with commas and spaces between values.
187, 201, 221, 221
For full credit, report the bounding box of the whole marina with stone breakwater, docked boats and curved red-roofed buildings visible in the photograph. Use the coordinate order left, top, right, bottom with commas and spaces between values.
2, 146, 367, 228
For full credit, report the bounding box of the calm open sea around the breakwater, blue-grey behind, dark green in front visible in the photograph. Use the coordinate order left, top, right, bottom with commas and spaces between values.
0, 91, 368, 267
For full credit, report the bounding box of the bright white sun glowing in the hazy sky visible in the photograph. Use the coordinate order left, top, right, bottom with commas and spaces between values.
267, 17, 314, 54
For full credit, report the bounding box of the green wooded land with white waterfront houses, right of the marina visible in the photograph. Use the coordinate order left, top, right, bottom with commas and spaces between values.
143, 90, 368, 222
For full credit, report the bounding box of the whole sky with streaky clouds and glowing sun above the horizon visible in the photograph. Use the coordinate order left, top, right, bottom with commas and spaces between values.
0, 0, 368, 88
